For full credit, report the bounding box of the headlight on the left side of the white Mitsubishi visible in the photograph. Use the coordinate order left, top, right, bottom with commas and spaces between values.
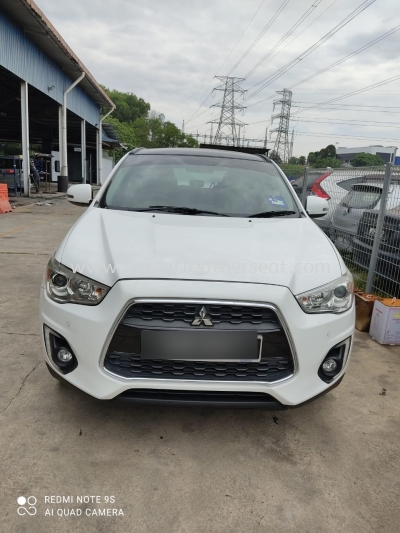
46, 257, 110, 305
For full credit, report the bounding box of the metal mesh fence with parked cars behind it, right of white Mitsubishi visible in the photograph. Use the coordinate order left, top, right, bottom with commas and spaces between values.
294, 163, 400, 298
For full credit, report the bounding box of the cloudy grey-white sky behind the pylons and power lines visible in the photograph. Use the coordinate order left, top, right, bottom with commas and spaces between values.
36, 0, 400, 156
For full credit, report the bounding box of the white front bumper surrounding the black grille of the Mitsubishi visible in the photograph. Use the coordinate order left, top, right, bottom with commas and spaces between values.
40, 280, 355, 406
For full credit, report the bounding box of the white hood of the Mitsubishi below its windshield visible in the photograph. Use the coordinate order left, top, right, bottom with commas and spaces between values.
56, 208, 345, 294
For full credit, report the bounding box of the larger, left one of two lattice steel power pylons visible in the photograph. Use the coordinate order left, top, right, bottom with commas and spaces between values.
211, 76, 246, 146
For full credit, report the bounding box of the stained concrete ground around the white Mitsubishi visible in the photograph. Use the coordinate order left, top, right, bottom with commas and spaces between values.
0, 199, 400, 533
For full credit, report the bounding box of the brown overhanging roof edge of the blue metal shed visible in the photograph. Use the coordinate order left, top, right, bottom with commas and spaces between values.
0, 0, 113, 107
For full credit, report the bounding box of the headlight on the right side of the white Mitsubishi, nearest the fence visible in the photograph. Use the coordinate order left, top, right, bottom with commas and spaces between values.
296, 271, 354, 313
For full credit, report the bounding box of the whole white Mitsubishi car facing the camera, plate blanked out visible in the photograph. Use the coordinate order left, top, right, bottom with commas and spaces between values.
40, 149, 355, 409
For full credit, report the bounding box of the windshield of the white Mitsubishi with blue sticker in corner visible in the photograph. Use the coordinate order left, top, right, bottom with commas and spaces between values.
100, 154, 299, 217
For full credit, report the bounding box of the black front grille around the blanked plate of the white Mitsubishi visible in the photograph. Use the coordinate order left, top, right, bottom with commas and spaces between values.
104, 303, 294, 383
